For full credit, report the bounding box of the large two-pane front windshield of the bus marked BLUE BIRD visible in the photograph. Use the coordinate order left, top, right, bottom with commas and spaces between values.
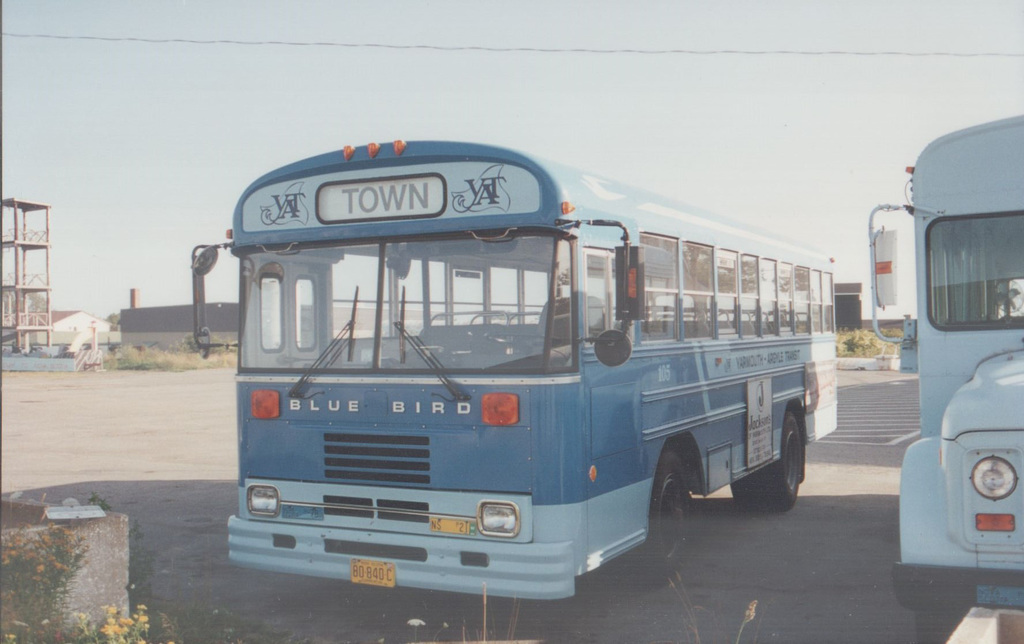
240, 233, 574, 373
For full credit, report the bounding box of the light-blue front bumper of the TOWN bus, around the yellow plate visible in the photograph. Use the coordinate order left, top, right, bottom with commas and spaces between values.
227, 516, 575, 599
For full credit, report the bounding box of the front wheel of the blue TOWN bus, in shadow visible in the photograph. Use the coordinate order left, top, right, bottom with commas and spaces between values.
646, 452, 690, 563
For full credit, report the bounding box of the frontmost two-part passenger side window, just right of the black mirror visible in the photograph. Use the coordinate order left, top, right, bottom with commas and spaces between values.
640, 234, 679, 340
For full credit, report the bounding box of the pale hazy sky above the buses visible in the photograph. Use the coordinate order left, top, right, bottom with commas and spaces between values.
2, 0, 1024, 317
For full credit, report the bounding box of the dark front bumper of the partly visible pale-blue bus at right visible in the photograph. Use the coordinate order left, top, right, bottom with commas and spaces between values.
893, 563, 1024, 611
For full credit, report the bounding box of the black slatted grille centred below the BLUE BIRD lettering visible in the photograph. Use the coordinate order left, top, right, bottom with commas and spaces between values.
324, 433, 430, 485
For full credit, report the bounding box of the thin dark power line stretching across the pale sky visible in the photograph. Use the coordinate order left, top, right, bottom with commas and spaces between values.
3, 32, 1024, 58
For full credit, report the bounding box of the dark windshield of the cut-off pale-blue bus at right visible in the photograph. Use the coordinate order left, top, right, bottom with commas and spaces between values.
928, 213, 1024, 330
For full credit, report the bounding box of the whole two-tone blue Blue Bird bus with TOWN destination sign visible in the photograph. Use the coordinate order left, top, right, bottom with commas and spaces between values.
193, 141, 836, 599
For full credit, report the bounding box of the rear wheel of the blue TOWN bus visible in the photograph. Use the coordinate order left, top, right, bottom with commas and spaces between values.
732, 412, 804, 512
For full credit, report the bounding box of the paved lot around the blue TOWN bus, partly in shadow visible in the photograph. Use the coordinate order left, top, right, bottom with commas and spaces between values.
2, 371, 912, 643
